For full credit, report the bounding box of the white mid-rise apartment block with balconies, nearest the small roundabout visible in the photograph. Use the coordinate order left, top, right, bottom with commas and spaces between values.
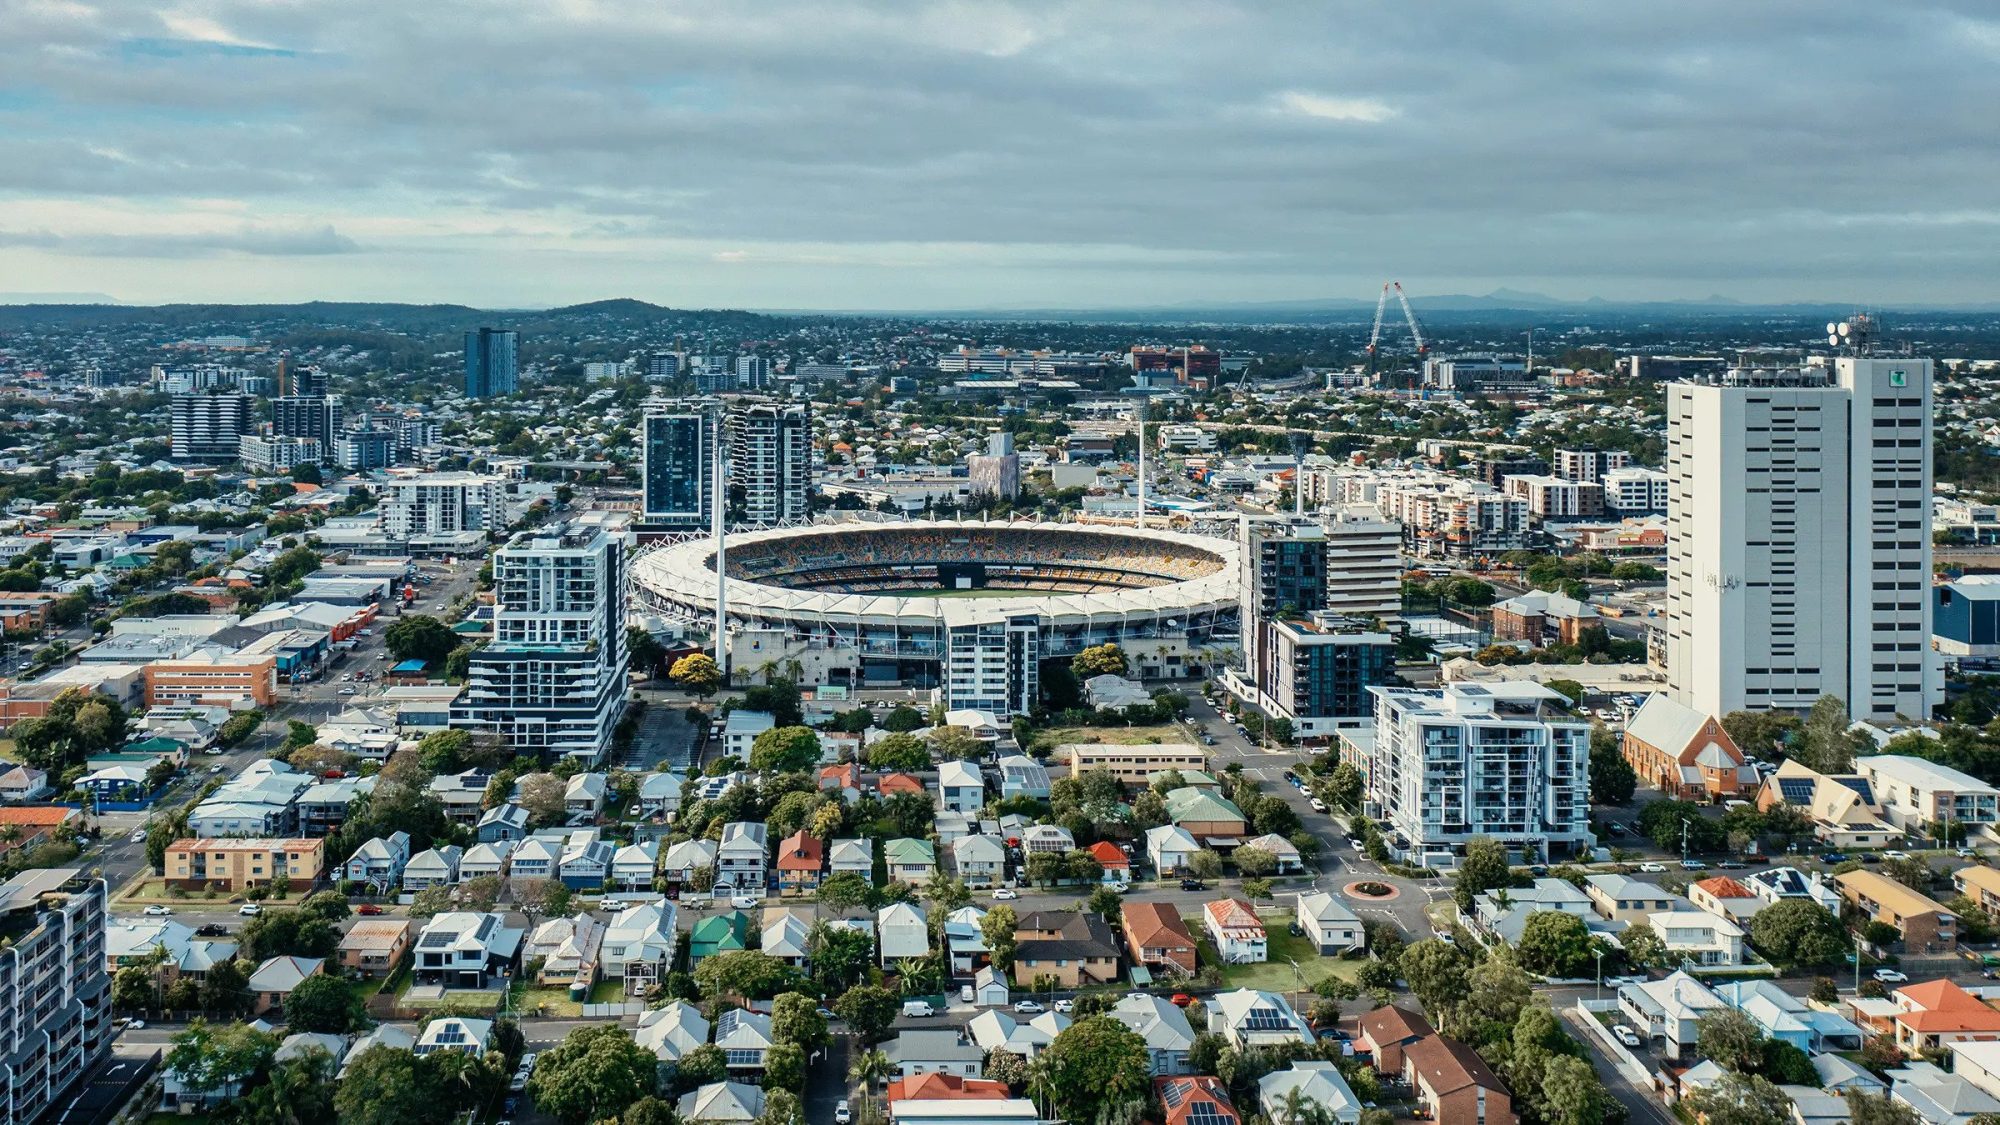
1368, 681, 1596, 867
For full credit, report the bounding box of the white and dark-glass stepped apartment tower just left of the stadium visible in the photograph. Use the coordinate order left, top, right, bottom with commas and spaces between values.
452, 518, 630, 765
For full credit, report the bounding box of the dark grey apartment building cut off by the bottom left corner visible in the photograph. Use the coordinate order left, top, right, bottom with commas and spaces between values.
0, 869, 112, 1123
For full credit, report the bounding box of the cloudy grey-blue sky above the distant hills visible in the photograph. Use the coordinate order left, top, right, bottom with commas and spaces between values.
0, 0, 2000, 308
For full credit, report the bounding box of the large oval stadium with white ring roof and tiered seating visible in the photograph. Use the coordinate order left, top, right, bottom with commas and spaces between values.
632, 520, 1238, 715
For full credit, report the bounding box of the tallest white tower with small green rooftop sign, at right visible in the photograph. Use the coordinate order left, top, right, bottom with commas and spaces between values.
1662, 356, 1942, 719
